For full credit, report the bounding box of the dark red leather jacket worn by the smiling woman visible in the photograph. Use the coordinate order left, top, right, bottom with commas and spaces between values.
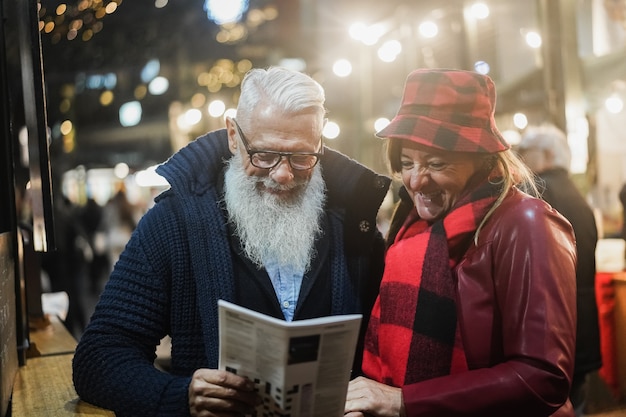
402, 189, 576, 417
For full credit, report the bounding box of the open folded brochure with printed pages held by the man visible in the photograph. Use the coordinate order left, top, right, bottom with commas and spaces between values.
218, 300, 362, 417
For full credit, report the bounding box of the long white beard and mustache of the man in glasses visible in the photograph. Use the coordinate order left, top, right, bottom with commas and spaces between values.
224, 153, 326, 272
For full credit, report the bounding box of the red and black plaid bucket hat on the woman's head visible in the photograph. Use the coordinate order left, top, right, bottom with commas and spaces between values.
376, 69, 510, 153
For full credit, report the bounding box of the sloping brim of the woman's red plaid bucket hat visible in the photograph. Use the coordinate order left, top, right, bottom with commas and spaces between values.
376, 114, 511, 153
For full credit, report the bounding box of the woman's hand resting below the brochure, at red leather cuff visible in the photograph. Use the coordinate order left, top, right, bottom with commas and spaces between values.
344, 376, 405, 417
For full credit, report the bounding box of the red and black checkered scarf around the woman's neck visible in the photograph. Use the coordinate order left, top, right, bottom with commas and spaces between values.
363, 182, 499, 387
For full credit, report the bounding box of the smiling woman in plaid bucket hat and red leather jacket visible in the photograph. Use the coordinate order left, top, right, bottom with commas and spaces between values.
345, 70, 576, 417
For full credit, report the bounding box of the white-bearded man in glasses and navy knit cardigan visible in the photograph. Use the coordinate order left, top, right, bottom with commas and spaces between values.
73, 67, 389, 416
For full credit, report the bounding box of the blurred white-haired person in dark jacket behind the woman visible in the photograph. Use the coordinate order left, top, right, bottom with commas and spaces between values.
519, 125, 602, 416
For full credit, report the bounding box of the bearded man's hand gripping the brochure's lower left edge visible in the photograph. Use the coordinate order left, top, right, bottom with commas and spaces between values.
189, 369, 261, 417
